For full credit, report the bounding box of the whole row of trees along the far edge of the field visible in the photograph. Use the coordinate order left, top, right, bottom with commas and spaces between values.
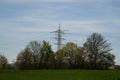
0, 33, 115, 69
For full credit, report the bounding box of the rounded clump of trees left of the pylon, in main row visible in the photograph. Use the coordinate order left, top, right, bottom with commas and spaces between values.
16, 41, 53, 69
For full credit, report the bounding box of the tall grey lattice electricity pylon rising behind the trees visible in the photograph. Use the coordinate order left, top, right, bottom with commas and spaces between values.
51, 24, 65, 50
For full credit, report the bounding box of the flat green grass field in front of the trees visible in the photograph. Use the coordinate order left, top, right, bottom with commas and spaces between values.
0, 70, 120, 80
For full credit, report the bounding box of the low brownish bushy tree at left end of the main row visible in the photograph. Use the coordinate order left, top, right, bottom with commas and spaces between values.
16, 49, 33, 69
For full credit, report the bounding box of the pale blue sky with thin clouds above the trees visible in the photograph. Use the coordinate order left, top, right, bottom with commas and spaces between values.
0, 0, 120, 64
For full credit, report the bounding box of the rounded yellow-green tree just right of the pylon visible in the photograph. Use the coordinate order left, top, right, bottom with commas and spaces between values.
57, 42, 83, 68
